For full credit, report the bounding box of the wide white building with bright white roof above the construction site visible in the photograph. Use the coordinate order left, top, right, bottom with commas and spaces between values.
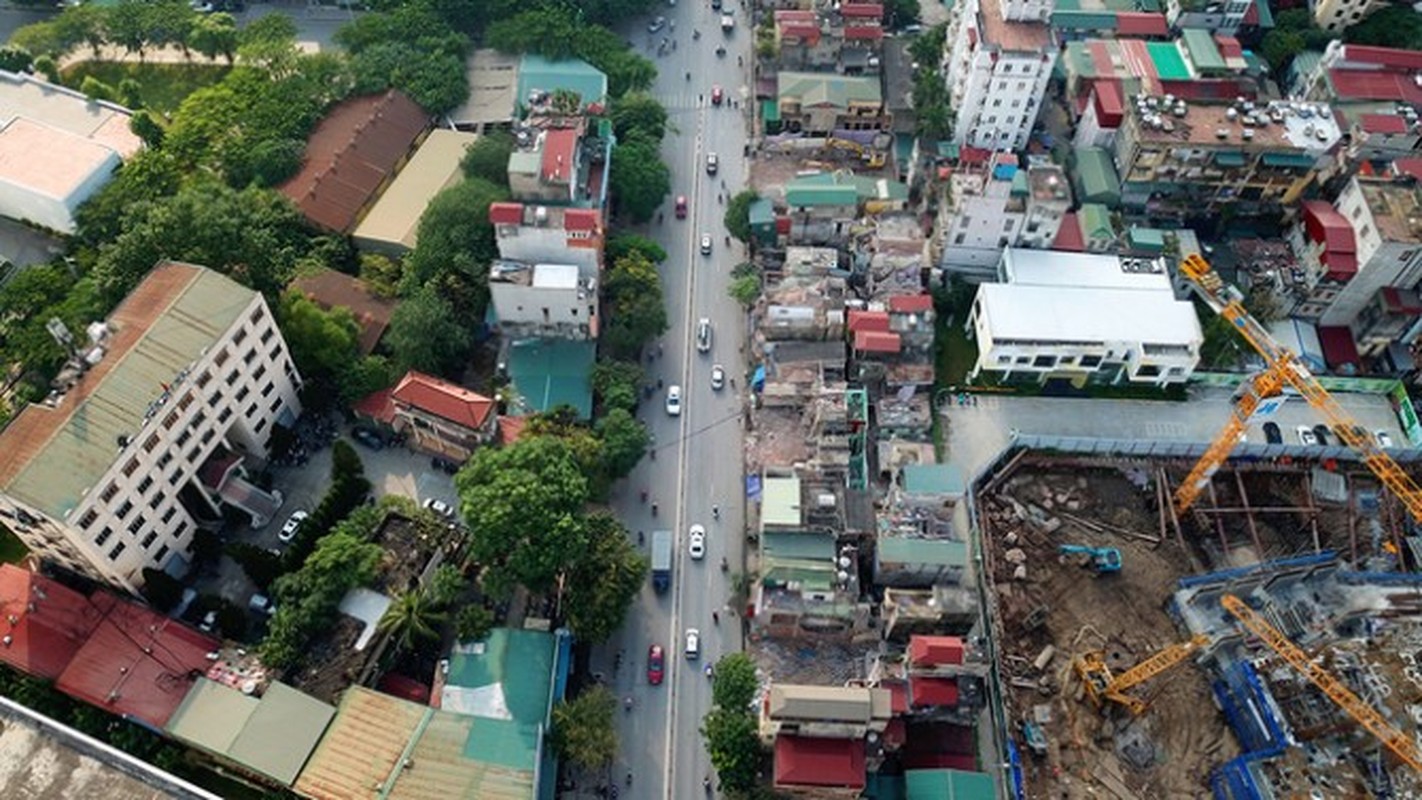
968, 249, 1204, 387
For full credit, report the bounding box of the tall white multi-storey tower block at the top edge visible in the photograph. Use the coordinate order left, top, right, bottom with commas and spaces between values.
943, 0, 1057, 151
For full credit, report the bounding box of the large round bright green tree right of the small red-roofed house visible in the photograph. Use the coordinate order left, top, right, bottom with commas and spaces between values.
455, 436, 589, 591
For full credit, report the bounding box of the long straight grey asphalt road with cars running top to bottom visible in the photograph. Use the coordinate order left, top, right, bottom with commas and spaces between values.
594, 0, 751, 799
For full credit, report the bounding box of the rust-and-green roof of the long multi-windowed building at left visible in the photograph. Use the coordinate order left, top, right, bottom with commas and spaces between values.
0, 261, 256, 519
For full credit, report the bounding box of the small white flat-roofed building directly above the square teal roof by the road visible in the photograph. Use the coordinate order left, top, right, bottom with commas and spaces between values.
489, 261, 597, 340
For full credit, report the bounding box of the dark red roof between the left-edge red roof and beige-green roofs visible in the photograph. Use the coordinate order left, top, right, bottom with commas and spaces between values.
55, 593, 219, 729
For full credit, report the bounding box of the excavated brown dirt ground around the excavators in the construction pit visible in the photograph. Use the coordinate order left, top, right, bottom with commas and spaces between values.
981, 466, 1239, 800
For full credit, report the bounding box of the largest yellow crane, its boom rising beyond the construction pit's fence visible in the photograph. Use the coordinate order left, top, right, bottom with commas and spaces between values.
1175, 254, 1422, 521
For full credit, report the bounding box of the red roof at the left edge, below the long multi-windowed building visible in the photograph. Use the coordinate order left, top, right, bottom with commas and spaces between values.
0, 564, 100, 681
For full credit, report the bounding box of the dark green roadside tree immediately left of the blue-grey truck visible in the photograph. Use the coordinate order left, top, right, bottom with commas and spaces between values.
563, 512, 648, 642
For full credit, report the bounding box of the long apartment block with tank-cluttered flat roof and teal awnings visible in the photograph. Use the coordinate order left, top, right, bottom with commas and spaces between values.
1115, 95, 1341, 219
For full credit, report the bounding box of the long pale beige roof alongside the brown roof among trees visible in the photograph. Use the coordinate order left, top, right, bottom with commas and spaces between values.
351, 128, 478, 250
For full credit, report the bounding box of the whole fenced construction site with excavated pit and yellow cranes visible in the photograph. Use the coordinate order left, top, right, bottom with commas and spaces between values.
973, 252, 1422, 800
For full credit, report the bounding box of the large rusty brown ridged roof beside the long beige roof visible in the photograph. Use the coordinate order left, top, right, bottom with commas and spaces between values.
279, 90, 429, 233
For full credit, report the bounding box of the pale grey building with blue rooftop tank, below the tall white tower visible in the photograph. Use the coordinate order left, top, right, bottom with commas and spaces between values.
937, 152, 1071, 280
